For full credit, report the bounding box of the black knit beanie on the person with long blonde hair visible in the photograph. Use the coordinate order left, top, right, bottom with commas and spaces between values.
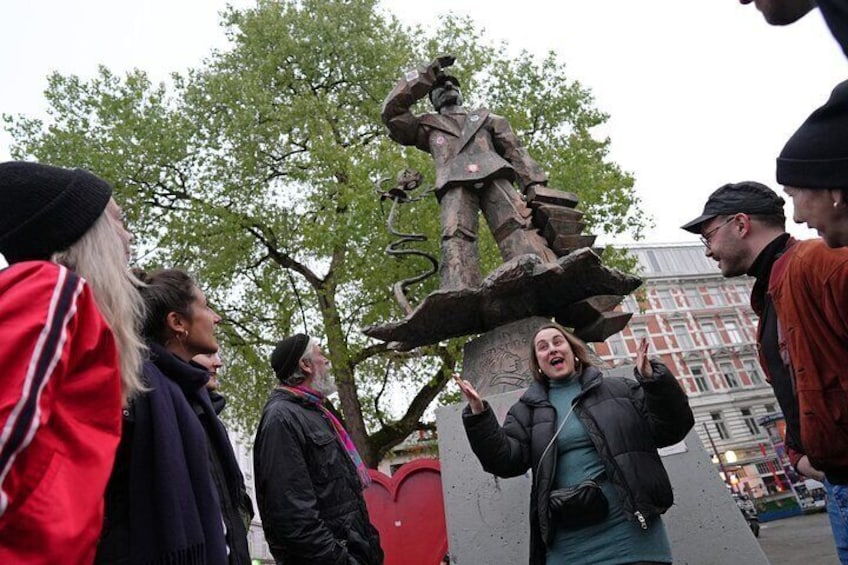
0, 161, 112, 264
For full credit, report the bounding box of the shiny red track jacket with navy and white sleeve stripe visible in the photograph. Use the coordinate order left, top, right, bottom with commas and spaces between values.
0, 261, 121, 564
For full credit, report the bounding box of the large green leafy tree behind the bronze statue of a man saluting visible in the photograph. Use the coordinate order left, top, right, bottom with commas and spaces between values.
4, 0, 644, 466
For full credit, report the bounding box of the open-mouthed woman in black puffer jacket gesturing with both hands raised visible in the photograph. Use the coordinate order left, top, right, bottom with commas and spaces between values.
459, 324, 694, 565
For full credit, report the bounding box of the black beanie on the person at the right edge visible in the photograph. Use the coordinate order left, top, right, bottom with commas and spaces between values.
777, 81, 848, 189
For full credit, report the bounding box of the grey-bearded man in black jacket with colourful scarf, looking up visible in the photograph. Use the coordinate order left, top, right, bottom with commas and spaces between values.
253, 334, 383, 565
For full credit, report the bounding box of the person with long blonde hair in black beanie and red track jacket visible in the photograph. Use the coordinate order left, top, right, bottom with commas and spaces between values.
0, 161, 144, 563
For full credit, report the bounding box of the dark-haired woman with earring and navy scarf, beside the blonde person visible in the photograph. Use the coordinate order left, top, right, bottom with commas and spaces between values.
96, 269, 250, 565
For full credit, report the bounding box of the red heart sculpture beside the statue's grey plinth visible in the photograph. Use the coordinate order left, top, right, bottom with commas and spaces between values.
365, 459, 448, 565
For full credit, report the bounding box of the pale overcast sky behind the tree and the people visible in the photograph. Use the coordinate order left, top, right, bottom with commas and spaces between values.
0, 0, 848, 242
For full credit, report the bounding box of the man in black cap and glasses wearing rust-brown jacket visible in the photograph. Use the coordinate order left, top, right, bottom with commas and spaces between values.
682, 181, 848, 563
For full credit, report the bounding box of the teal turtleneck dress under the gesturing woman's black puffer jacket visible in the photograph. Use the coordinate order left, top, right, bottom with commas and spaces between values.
546, 375, 671, 565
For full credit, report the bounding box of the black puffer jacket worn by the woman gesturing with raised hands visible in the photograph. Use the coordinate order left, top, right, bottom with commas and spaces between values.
463, 362, 694, 565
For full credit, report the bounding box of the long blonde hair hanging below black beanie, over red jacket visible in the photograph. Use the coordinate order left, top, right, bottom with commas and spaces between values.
50, 205, 147, 402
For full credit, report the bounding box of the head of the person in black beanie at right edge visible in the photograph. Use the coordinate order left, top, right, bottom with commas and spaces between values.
777, 81, 848, 247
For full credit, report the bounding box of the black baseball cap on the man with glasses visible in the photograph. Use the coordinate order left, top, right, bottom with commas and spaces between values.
680, 181, 785, 233
